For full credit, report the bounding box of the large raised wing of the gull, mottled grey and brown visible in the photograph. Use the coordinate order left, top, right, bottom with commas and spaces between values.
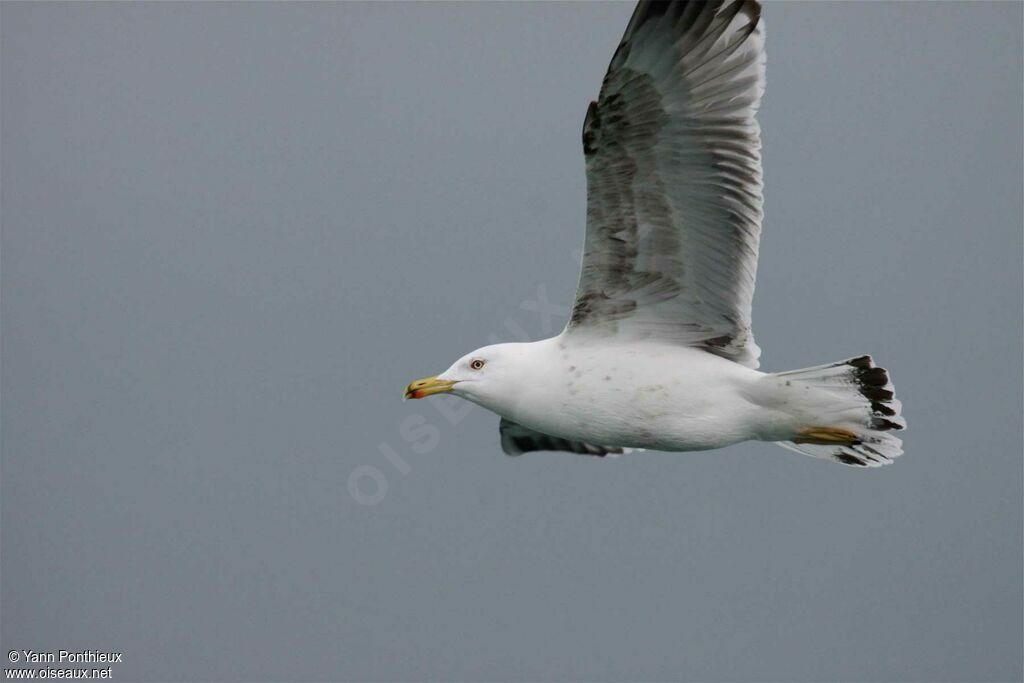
565, 0, 765, 368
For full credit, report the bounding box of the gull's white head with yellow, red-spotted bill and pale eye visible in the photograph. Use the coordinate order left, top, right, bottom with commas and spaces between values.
406, 344, 534, 410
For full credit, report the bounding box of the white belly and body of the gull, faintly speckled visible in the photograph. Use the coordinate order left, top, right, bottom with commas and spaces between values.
503, 340, 764, 451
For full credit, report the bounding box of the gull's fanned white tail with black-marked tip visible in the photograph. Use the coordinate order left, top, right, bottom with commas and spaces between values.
773, 355, 906, 467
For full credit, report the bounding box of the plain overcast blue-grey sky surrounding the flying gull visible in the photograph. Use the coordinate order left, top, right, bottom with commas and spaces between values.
0, 2, 1024, 681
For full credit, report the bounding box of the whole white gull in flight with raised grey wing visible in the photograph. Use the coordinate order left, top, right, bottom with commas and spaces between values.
406, 0, 906, 467
